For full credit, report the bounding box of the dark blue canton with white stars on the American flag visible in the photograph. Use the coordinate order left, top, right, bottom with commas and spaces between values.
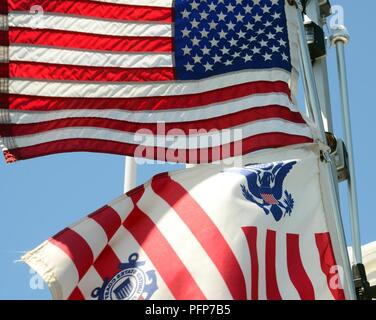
175, 0, 292, 80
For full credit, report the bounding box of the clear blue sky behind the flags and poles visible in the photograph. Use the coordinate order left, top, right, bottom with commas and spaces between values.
0, 0, 376, 299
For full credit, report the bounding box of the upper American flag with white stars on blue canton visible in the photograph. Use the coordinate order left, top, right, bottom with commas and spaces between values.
0, 0, 314, 163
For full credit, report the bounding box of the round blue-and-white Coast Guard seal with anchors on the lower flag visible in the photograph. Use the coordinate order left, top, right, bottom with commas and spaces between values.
91, 253, 158, 300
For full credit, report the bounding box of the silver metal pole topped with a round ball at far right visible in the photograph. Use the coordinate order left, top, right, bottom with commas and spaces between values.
330, 26, 362, 264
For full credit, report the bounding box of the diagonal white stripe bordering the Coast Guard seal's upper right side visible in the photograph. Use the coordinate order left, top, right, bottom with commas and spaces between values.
110, 227, 174, 300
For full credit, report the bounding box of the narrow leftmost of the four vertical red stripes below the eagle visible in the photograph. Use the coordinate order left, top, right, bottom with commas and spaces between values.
242, 227, 259, 300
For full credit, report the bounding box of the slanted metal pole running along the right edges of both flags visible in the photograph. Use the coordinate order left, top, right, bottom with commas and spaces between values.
295, 0, 356, 300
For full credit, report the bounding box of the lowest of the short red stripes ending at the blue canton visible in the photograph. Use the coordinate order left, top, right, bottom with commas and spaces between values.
8, 62, 174, 82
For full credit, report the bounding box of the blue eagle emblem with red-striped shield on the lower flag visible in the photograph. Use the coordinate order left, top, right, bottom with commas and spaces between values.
226, 161, 296, 221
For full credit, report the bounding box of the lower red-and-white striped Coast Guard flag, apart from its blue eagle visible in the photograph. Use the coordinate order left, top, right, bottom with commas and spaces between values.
23, 147, 345, 300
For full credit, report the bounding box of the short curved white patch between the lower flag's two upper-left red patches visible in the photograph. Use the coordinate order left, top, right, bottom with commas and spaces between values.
70, 218, 108, 260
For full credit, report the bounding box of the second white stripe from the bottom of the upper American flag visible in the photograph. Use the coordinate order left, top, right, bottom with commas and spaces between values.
6, 93, 298, 124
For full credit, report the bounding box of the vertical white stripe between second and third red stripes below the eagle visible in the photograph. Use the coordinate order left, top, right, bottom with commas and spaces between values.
274, 231, 300, 300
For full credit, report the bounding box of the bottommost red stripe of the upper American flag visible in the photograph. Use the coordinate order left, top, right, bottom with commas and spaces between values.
4, 132, 313, 163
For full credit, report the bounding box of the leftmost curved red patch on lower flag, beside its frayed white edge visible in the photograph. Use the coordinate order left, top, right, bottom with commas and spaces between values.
49, 228, 94, 280
